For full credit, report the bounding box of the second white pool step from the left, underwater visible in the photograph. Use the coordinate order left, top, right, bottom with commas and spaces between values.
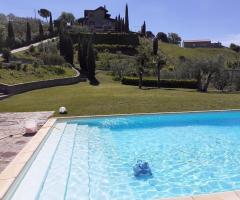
39, 124, 77, 200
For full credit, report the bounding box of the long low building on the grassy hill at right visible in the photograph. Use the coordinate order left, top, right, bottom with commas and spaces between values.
183, 40, 223, 48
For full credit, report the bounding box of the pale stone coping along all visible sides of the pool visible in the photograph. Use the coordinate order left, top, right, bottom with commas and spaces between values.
0, 109, 240, 200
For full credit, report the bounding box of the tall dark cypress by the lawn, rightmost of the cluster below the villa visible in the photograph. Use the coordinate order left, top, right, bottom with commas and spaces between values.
87, 40, 96, 81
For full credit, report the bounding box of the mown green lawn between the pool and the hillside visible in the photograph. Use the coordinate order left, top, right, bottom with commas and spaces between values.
0, 73, 240, 116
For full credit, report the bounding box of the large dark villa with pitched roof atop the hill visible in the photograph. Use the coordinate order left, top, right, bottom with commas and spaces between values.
78, 6, 116, 32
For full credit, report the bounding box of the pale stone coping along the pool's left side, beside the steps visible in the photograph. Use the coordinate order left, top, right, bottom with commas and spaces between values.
0, 118, 57, 200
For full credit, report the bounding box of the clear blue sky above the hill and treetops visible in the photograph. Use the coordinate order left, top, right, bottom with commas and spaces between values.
0, 0, 240, 45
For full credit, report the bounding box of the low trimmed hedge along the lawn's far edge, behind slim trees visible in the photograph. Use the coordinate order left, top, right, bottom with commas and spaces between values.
122, 77, 198, 89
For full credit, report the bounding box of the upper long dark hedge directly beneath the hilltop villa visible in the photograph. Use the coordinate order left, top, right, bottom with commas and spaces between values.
70, 33, 139, 46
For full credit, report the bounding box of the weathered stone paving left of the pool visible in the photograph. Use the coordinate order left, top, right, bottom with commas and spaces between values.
0, 111, 54, 173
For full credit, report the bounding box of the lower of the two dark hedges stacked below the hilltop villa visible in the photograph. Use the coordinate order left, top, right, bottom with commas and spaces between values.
94, 44, 137, 56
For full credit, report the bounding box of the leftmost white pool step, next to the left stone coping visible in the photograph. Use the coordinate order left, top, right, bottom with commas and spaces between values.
11, 123, 66, 200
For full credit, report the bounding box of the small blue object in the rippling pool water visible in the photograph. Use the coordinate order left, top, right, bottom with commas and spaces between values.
133, 160, 152, 177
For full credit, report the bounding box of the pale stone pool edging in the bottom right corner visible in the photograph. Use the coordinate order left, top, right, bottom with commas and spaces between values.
160, 191, 240, 200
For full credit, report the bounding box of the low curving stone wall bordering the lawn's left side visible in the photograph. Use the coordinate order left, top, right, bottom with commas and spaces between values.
0, 70, 86, 95
